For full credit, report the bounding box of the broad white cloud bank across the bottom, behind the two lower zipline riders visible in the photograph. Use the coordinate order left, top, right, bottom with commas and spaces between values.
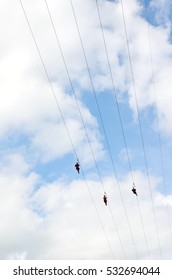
0, 158, 172, 259
